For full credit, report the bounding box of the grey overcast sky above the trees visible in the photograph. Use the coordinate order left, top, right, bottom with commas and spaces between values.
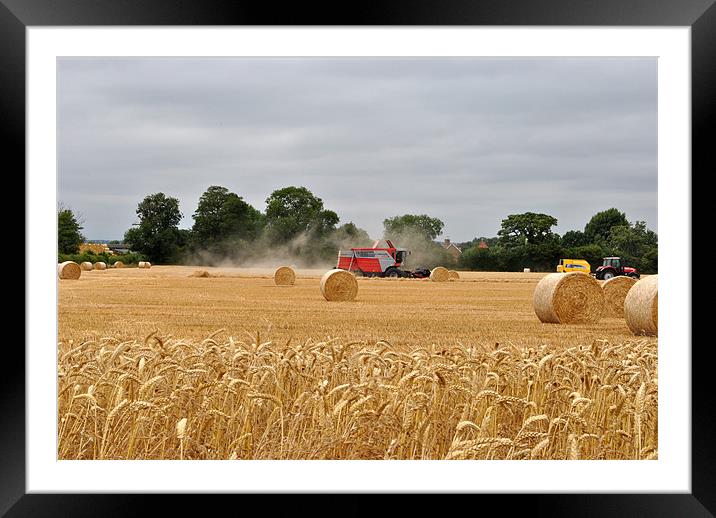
58, 58, 658, 241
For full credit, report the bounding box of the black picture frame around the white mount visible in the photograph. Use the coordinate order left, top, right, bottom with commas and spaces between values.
0, 0, 716, 517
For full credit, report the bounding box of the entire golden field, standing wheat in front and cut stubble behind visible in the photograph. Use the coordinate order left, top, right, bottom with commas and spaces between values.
58, 266, 658, 459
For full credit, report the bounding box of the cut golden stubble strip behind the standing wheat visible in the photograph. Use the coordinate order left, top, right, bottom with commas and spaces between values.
59, 266, 633, 348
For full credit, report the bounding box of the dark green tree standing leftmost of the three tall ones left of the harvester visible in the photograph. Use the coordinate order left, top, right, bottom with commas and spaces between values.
124, 192, 182, 264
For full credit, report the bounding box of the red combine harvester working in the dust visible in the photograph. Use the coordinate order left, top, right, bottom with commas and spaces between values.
336, 240, 430, 278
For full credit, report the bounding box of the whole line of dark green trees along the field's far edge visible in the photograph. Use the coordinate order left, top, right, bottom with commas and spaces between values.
58, 185, 658, 273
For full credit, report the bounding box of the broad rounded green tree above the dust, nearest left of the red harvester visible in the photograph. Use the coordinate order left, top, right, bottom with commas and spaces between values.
266, 186, 339, 242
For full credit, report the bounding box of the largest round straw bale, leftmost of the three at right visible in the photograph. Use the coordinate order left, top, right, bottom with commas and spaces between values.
532, 272, 604, 324
